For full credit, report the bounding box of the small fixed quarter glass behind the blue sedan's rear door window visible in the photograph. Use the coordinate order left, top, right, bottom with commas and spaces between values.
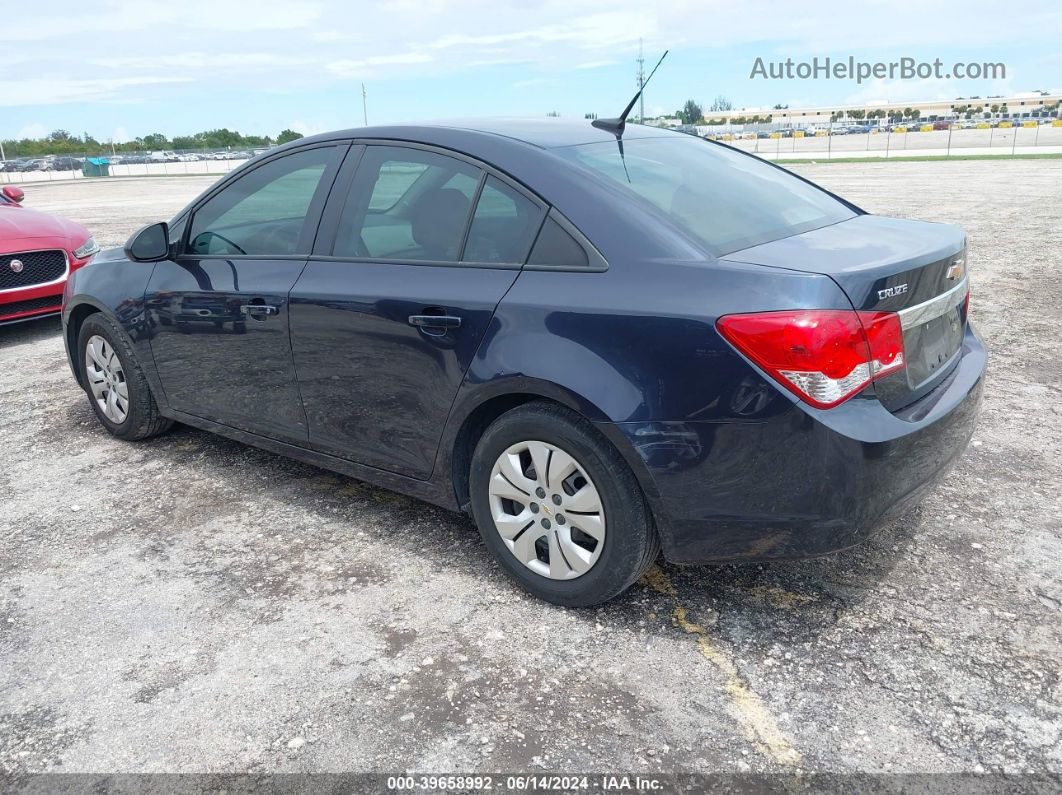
462, 176, 546, 264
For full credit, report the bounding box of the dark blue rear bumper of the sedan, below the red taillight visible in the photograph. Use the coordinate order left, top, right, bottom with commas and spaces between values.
609, 318, 986, 563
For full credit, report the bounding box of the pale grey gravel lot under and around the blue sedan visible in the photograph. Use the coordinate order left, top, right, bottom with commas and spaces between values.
0, 160, 1062, 775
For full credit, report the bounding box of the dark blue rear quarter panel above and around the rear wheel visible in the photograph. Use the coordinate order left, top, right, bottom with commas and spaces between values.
435, 255, 851, 539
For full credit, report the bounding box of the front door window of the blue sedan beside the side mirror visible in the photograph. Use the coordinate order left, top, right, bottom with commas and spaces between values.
188, 146, 339, 256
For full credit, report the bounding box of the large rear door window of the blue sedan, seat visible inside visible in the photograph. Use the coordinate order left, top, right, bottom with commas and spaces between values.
333, 145, 481, 262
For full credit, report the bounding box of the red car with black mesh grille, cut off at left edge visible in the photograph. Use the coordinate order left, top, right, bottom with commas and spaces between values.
0, 185, 100, 325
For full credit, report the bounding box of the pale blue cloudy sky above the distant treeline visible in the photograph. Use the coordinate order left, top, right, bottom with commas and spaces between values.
0, 0, 1062, 141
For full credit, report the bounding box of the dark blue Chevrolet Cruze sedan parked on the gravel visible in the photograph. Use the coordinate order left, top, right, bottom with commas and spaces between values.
64, 120, 986, 606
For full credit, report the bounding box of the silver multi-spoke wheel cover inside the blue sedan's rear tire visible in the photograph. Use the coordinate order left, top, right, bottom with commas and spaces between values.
487, 442, 605, 580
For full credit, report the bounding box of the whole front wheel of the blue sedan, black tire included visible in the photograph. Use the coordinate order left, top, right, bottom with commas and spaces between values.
75, 313, 173, 442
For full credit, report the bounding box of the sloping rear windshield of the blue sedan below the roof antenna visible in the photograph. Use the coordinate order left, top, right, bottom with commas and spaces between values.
554, 136, 856, 257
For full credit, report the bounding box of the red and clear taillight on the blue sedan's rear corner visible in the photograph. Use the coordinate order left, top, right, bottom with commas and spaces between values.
717, 309, 904, 409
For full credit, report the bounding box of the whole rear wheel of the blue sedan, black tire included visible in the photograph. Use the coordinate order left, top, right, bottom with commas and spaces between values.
468, 402, 660, 607
